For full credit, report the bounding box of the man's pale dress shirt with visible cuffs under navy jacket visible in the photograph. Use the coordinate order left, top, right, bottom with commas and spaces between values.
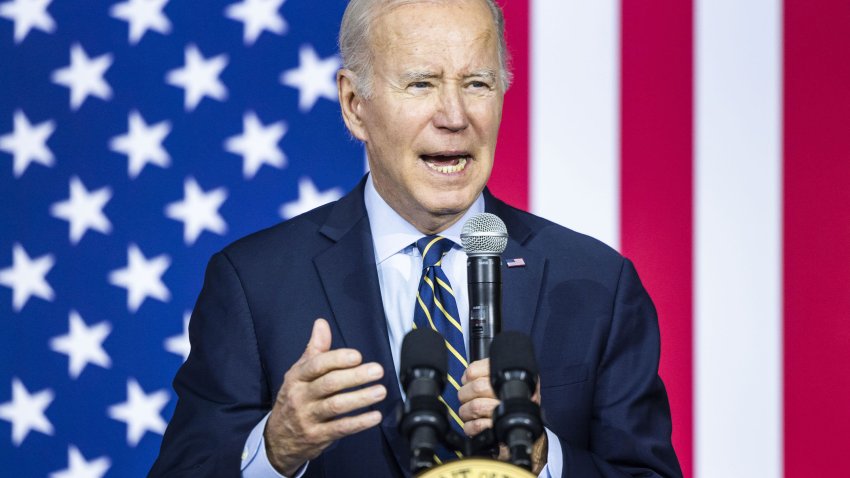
242, 176, 563, 478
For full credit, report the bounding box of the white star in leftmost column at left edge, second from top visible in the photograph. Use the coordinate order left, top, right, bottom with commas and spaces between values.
0, 110, 56, 178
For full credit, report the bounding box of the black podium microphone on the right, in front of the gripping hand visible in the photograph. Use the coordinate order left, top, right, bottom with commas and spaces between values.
490, 332, 543, 470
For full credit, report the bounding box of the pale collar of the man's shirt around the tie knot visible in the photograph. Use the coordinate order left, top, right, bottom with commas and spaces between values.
363, 174, 484, 264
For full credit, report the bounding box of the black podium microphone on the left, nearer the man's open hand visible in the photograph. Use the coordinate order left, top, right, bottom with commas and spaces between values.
399, 329, 449, 474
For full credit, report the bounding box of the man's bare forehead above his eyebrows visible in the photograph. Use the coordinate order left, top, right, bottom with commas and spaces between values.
370, 0, 498, 67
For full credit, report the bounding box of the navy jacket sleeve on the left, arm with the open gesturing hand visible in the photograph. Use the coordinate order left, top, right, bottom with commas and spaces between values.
149, 253, 271, 477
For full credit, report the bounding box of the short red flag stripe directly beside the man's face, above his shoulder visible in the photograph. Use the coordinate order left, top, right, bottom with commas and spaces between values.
487, 0, 531, 210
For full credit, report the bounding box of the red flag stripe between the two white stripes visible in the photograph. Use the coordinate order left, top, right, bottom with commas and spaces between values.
621, 0, 693, 476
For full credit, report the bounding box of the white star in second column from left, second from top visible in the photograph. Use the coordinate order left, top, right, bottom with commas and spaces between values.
50, 176, 112, 244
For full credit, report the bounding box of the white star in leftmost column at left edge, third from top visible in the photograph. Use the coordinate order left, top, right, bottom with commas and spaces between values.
0, 243, 55, 312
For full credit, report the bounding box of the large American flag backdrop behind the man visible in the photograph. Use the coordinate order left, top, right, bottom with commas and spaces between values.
0, 0, 850, 478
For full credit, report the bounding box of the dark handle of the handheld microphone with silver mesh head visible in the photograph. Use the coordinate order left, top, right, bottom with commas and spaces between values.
466, 256, 502, 362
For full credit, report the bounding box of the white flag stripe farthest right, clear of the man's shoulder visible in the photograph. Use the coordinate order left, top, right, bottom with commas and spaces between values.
695, 0, 780, 478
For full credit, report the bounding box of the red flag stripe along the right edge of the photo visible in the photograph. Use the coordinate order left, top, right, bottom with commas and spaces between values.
783, 0, 850, 478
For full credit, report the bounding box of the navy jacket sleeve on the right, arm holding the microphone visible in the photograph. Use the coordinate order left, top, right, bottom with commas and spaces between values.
548, 259, 682, 478
